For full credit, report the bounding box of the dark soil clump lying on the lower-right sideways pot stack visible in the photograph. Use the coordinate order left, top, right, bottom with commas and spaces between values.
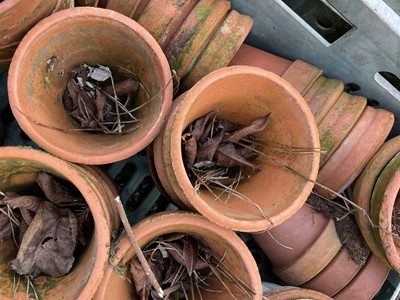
306, 194, 369, 265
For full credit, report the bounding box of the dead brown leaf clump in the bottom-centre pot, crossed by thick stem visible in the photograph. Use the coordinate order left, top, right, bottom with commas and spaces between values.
130, 233, 212, 299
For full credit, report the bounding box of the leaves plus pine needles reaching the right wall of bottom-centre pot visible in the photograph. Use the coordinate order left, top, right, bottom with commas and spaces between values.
130, 233, 254, 299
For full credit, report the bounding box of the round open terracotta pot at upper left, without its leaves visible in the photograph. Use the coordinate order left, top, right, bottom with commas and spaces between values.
8, 7, 172, 164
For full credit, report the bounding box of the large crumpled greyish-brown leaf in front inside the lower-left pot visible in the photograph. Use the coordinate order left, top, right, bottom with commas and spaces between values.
10, 201, 78, 277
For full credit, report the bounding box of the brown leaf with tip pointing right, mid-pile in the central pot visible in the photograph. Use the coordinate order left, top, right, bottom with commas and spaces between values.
215, 143, 261, 171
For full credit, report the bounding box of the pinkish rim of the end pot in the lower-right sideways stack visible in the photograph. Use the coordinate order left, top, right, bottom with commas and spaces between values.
334, 254, 389, 300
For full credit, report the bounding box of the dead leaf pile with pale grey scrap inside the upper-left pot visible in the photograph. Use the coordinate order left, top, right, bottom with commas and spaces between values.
63, 63, 139, 134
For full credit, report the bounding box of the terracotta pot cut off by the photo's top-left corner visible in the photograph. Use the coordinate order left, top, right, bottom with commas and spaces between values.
0, 0, 74, 71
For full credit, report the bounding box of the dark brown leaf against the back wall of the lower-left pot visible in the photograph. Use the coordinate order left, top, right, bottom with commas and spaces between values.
36, 172, 82, 204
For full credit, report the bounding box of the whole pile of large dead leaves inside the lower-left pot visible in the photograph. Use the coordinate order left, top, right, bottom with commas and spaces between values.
0, 172, 88, 277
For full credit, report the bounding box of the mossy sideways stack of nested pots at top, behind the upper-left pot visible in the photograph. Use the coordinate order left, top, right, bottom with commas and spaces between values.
77, 0, 253, 91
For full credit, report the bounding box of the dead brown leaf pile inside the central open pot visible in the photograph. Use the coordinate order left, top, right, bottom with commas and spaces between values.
182, 110, 269, 185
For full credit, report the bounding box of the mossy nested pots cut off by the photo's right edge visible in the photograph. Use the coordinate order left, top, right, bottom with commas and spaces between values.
354, 136, 400, 272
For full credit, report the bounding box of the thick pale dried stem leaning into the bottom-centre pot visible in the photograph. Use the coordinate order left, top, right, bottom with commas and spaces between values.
115, 196, 164, 297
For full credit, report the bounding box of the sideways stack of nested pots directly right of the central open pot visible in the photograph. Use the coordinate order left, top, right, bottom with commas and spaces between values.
230, 45, 394, 199
